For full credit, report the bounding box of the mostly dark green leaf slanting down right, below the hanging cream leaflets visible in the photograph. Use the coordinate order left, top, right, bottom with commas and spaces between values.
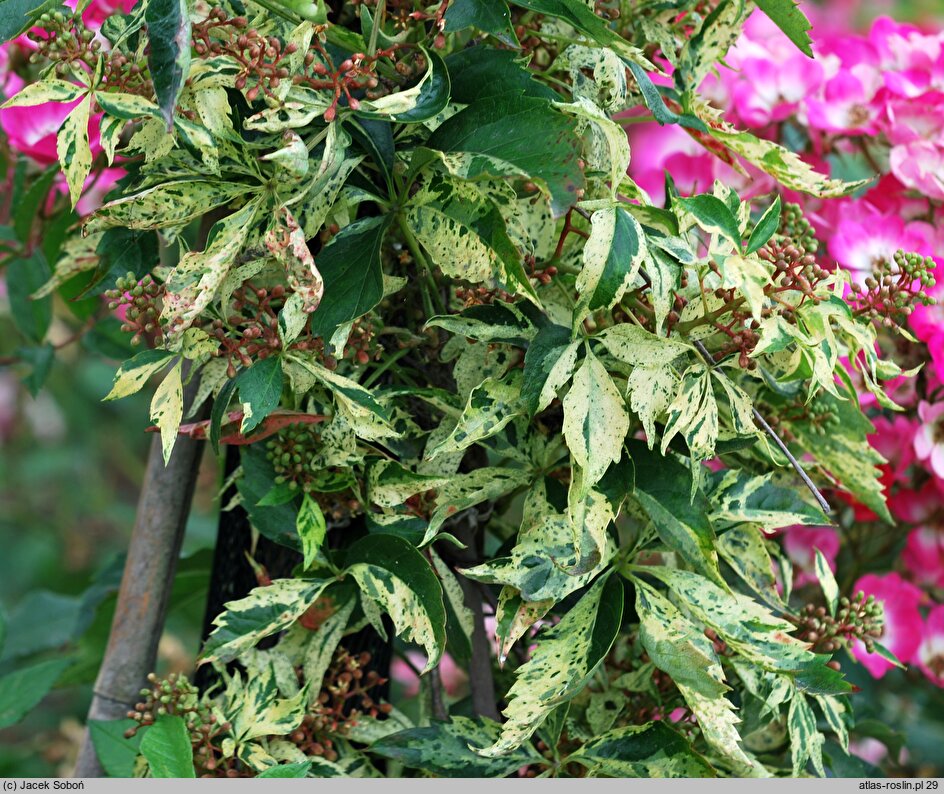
627, 440, 724, 586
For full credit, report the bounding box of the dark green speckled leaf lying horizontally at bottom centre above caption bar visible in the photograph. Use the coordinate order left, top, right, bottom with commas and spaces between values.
370, 717, 543, 778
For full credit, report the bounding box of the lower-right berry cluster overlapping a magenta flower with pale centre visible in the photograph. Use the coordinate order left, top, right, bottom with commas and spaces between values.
795, 591, 885, 666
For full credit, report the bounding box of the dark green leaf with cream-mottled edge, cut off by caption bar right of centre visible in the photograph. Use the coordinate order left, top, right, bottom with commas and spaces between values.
567, 722, 715, 778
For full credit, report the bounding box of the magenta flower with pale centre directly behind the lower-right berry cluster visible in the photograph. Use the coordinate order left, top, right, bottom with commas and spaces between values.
852, 573, 924, 678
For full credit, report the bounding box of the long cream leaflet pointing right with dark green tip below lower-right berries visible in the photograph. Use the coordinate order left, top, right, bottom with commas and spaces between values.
647, 566, 852, 695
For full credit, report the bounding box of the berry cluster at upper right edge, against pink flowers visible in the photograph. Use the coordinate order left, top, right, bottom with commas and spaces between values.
851, 249, 936, 327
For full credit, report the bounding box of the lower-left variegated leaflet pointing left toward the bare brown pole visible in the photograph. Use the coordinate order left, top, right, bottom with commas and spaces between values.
202, 579, 332, 662
